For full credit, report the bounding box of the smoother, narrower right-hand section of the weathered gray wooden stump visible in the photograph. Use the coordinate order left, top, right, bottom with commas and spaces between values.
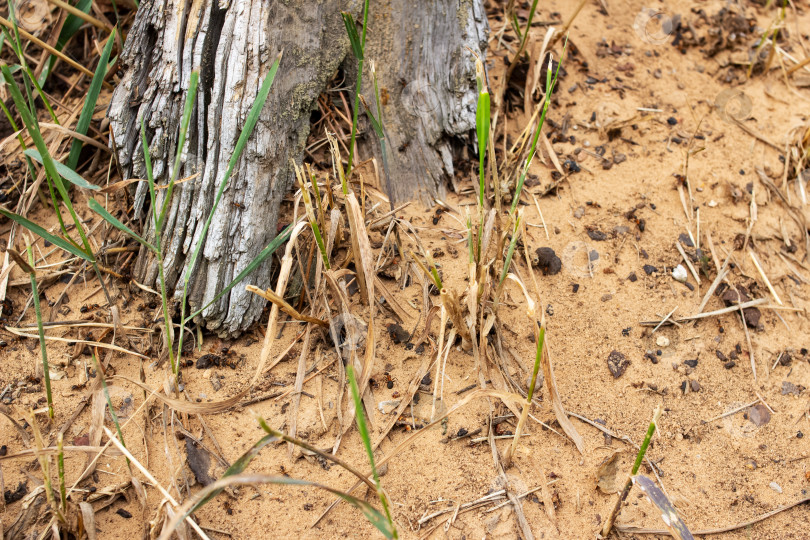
361, 0, 488, 205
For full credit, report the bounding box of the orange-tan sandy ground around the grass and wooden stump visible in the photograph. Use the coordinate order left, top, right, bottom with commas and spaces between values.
0, 0, 810, 539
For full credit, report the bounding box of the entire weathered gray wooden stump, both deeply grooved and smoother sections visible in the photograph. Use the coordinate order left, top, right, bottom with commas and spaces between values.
109, 0, 486, 335
